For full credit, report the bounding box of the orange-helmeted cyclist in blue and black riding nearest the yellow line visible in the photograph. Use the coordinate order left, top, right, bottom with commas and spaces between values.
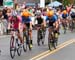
46, 10, 59, 37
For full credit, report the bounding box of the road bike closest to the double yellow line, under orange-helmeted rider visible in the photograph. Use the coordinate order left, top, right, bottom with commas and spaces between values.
48, 27, 58, 50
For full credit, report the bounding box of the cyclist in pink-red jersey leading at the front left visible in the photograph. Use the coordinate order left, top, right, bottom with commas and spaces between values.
9, 15, 23, 45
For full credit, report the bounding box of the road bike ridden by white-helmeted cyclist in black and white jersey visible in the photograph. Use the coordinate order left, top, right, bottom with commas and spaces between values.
36, 24, 46, 46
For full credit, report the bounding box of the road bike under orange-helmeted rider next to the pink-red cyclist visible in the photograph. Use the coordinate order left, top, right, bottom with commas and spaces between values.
23, 27, 32, 52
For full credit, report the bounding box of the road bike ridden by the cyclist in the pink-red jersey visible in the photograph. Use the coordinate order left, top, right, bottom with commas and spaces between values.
10, 30, 22, 59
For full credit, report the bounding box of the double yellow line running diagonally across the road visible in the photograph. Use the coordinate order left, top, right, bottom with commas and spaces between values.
30, 39, 75, 60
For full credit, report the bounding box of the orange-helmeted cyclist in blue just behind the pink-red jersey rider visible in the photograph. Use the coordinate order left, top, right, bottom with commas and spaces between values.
22, 9, 33, 47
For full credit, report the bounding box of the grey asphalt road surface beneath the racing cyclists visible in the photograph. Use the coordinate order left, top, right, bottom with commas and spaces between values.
0, 30, 75, 60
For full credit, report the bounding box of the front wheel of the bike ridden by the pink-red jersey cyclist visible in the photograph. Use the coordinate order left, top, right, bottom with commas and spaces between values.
10, 37, 16, 59
